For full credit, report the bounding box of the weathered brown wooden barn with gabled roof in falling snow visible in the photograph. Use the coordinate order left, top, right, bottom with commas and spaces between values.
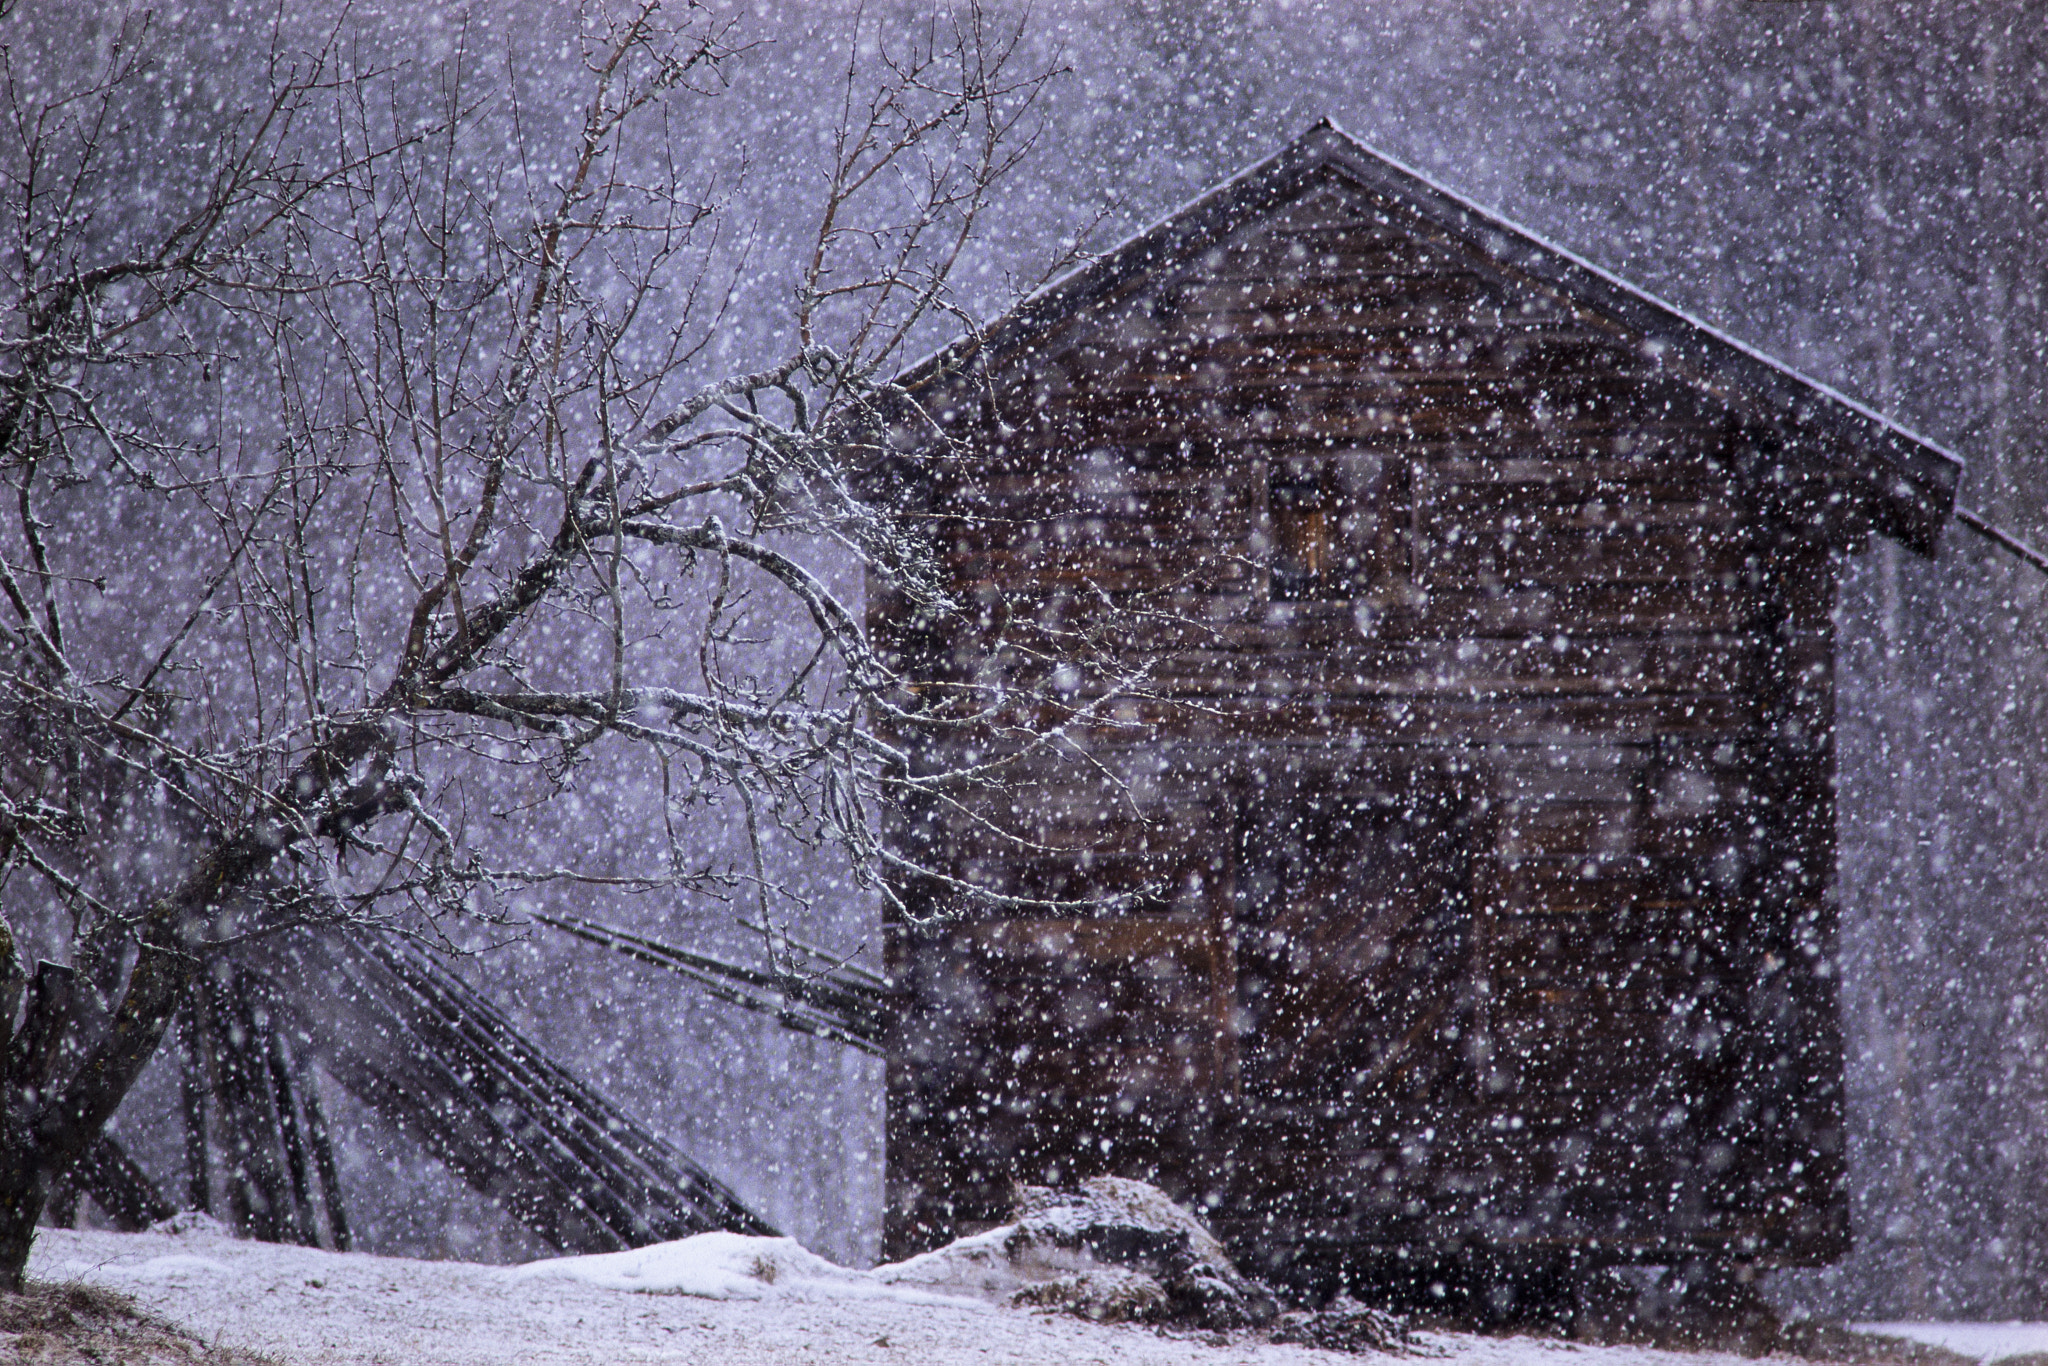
870, 125, 1960, 1286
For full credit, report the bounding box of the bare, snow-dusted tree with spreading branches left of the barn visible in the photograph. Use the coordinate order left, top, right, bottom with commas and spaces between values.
0, 0, 1120, 1288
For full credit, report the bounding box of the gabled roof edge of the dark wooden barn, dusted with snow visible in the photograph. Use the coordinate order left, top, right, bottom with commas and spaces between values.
901, 119, 1962, 553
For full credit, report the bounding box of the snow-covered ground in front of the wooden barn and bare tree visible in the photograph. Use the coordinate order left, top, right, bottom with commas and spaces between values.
29, 1223, 2048, 1366
